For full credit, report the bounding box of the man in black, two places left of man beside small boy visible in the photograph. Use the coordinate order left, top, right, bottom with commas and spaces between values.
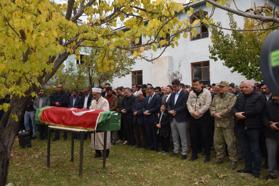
121, 88, 135, 145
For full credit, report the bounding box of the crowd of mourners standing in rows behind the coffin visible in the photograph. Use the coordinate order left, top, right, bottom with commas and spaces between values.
15, 79, 279, 179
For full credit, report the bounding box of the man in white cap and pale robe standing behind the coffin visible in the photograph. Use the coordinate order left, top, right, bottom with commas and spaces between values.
90, 88, 111, 158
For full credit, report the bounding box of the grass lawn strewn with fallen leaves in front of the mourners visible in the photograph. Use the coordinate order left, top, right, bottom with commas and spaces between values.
8, 140, 279, 186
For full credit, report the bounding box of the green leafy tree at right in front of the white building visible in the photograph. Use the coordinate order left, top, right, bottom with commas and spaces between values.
210, 11, 278, 81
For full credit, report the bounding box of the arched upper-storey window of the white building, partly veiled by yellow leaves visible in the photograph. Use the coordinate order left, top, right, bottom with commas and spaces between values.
190, 10, 208, 40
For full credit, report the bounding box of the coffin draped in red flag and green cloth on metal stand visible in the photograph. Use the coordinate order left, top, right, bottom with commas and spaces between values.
36, 107, 121, 131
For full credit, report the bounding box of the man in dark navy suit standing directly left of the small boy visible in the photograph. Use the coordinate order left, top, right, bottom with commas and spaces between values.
143, 84, 161, 150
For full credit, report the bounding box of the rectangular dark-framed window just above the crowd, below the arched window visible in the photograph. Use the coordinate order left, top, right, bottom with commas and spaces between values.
191, 61, 210, 85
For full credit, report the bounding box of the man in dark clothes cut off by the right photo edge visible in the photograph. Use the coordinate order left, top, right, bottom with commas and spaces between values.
264, 96, 279, 179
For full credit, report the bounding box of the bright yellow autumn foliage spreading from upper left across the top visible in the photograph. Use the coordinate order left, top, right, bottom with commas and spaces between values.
0, 0, 203, 97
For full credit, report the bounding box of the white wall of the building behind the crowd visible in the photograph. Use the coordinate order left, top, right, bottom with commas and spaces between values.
112, 0, 264, 87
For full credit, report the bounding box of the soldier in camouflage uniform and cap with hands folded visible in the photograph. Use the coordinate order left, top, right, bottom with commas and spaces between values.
210, 81, 237, 169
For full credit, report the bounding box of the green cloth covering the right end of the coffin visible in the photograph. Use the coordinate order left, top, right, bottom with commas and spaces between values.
97, 111, 121, 131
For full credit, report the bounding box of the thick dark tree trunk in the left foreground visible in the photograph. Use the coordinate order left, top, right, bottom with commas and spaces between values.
0, 97, 28, 186
